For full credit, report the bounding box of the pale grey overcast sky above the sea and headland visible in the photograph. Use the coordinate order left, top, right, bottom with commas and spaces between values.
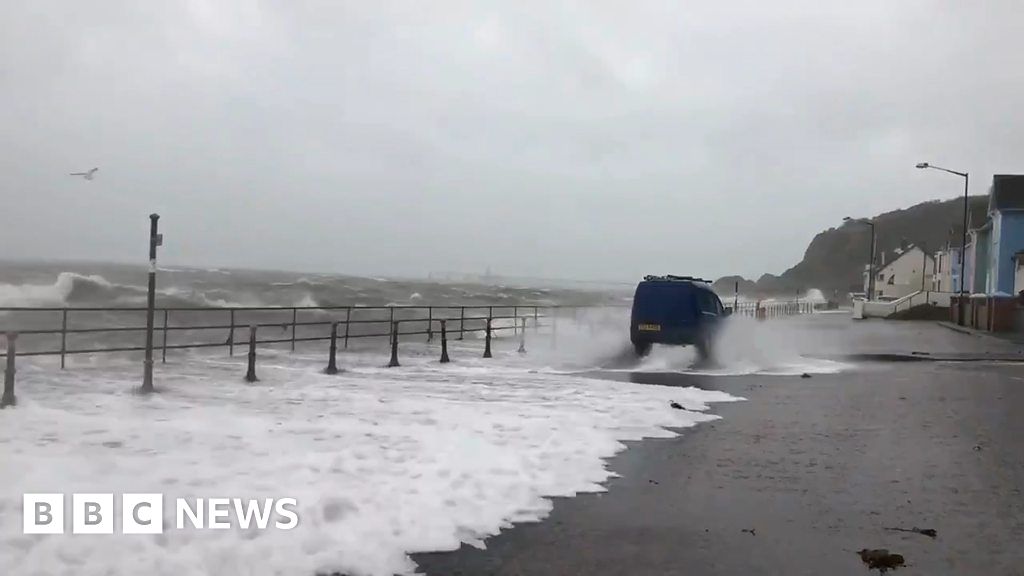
0, 0, 1024, 280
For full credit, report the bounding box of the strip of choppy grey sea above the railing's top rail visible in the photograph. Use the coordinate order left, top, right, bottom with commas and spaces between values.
0, 262, 630, 307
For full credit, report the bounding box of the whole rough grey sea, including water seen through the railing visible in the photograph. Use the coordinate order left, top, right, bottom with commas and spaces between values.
0, 262, 630, 354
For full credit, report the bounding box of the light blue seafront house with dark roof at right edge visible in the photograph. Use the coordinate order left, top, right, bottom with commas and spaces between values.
965, 174, 1024, 294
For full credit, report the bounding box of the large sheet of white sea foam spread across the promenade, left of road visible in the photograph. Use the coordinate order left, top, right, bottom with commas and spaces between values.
0, 330, 736, 576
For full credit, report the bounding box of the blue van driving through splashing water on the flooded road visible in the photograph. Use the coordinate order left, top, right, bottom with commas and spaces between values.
630, 276, 730, 360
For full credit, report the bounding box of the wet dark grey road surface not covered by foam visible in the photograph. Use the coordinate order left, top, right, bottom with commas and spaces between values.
415, 319, 1024, 576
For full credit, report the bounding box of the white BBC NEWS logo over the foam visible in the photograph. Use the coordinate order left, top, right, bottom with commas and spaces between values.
22, 493, 299, 534
